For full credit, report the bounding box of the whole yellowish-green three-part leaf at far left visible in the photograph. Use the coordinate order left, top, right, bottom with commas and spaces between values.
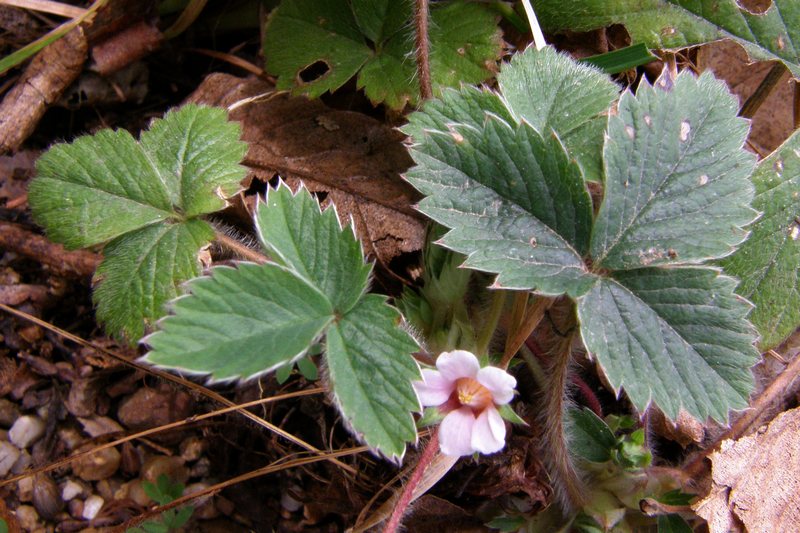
28, 104, 247, 342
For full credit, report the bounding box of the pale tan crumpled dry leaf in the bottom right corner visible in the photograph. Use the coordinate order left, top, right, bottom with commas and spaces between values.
692, 408, 800, 533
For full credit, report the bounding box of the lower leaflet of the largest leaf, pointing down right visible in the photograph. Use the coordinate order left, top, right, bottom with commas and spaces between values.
578, 267, 758, 421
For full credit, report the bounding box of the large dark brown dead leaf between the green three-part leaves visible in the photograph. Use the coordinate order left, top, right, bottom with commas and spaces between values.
189, 74, 425, 265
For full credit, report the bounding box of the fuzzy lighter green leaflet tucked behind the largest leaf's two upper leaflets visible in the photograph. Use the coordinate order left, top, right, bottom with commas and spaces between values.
497, 47, 618, 181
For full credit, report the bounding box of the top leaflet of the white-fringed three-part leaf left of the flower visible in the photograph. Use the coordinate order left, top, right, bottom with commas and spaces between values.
255, 184, 372, 314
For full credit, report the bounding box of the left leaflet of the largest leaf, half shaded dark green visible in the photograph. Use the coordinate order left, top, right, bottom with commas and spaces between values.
406, 117, 592, 294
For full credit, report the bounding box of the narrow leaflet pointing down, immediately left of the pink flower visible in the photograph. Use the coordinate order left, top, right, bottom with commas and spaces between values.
327, 294, 421, 458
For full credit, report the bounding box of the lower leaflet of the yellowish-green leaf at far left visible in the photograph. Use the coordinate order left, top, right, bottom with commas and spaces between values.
93, 220, 214, 339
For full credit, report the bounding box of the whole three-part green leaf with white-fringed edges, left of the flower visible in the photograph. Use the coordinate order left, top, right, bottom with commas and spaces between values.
145, 184, 420, 458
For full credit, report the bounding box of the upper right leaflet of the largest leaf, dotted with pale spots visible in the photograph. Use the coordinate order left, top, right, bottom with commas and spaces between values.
591, 72, 755, 270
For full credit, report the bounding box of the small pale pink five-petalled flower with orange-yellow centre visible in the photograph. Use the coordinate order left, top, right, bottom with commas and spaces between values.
414, 350, 517, 456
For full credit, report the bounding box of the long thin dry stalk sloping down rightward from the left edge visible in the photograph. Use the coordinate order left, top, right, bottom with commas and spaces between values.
0, 303, 357, 475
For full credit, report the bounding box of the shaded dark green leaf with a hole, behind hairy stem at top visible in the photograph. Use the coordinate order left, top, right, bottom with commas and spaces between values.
264, 0, 502, 109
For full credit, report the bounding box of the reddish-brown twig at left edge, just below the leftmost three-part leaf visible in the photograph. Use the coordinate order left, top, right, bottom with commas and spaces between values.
0, 222, 103, 278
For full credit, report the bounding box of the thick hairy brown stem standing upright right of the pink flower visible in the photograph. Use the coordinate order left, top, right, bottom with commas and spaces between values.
541, 324, 587, 513
